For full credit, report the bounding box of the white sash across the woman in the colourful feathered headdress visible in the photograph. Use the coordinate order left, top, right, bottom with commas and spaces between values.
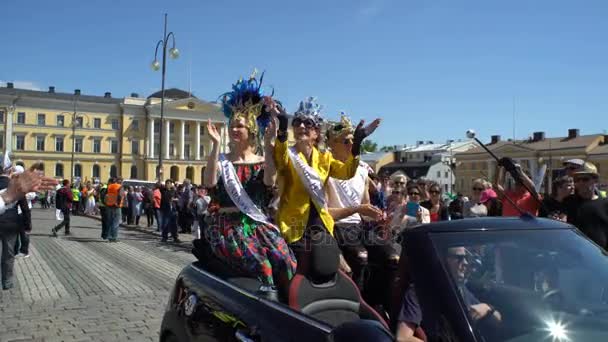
219, 154, 279, 231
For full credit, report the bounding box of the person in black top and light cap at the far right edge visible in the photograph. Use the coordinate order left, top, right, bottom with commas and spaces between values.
564, 162, 608, 249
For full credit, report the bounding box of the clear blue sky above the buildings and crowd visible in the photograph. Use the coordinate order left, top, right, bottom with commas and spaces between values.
0, 0, 608, 145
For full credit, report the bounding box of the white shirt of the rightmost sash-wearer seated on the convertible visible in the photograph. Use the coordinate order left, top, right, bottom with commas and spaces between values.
327, 162, 369, 224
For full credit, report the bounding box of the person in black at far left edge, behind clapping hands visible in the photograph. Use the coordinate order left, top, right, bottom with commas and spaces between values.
0, 163, 31, 290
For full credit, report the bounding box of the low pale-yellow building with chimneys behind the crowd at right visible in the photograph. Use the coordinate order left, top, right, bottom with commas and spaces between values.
455, 129, 608, 196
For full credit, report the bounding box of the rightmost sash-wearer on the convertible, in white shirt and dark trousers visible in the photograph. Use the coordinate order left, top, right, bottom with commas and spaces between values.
325, 113, 399, 291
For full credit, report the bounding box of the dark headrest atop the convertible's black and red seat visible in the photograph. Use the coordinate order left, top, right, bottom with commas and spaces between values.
310, 232, 340, 282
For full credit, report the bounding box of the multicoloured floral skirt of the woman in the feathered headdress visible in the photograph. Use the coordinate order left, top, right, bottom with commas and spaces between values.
204, 214, 297, 286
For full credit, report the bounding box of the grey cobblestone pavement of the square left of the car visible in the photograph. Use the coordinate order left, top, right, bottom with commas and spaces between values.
0, 209, 194, 342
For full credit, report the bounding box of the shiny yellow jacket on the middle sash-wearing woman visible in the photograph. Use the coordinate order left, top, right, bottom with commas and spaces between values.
274, 139, 359, 243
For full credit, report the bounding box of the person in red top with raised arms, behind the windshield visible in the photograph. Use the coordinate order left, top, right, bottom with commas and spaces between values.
496, 158, 542, 216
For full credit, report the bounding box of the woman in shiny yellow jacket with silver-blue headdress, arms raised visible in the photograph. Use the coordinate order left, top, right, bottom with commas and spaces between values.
273, 97, 380, 272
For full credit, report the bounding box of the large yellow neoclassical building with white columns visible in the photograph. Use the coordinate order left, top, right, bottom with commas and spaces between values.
0, 83, 228, 183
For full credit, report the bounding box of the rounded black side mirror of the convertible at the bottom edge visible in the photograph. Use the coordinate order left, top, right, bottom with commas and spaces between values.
329, 319, 395, 342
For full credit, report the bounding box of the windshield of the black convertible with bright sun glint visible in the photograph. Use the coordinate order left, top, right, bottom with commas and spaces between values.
433, 230, 608, 341
